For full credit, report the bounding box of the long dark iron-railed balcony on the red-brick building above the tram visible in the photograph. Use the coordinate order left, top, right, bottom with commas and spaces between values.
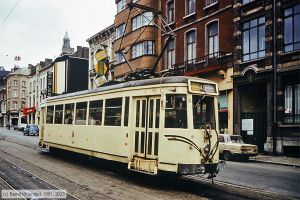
170, 52, 233, 76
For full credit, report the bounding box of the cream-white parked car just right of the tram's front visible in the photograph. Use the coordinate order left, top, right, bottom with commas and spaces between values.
219, 134, 258, 160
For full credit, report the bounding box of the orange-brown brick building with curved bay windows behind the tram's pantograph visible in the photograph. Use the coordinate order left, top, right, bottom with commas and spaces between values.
113, 0, 161, 80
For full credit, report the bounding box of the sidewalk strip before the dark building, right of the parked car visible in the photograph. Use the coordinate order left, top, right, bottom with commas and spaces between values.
250, 155, 300, 168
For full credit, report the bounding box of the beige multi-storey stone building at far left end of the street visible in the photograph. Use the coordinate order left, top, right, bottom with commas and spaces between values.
5, 67, 30, 126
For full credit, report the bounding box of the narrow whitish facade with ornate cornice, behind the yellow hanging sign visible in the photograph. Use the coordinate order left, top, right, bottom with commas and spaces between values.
86, 24, 116, 89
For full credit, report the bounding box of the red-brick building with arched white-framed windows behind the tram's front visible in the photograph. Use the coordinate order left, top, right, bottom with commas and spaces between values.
161, 0, 233, 133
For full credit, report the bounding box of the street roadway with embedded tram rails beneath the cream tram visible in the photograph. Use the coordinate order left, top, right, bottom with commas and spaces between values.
0, 129, 300, 199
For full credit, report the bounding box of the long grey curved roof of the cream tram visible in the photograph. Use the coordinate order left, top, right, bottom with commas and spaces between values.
48, 76, 214, 100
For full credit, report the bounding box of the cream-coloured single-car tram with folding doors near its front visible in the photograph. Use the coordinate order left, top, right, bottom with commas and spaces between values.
39, 77, 224, 175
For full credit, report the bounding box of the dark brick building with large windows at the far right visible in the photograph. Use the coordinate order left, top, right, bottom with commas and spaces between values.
233, 0, 300, 154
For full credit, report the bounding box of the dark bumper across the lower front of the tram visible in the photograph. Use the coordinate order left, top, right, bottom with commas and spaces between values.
178, 161, 225, 175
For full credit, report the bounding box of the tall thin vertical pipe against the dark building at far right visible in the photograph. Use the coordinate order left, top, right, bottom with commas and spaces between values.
272, 0, 277, 154
